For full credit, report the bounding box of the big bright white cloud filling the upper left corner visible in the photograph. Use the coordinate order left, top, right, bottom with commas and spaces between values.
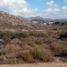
0, 0, 37, 16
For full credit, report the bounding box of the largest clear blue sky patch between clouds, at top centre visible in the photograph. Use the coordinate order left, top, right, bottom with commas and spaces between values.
27, 0, 46, 10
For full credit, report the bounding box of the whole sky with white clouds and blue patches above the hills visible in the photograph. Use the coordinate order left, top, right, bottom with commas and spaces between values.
0, 0, 67, 19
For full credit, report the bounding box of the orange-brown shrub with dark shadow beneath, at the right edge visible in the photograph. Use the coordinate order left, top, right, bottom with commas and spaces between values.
53, 44, 67, 57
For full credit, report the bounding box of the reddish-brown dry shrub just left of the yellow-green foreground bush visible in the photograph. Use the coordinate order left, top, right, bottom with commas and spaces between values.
17, 50, 34, 63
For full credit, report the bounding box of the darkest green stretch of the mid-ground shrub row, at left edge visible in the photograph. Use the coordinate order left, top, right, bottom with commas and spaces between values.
0, 31, 28, 39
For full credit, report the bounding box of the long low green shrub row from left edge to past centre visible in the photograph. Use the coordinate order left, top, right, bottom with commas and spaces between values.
0, 31, 48, 39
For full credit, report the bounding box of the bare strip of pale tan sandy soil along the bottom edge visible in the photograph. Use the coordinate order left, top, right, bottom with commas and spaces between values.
0, 63, 67, 67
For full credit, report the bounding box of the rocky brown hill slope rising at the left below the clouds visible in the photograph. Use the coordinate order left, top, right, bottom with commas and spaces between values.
0, 12, 31, 30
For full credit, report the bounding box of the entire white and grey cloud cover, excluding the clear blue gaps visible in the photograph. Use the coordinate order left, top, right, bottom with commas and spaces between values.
0, 0, 67, 18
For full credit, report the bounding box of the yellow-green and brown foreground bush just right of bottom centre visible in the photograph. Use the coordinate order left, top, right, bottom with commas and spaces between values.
34, 47, 53, 62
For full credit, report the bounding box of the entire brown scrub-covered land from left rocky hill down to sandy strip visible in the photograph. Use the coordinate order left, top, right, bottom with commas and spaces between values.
0, 12, 67, 64
